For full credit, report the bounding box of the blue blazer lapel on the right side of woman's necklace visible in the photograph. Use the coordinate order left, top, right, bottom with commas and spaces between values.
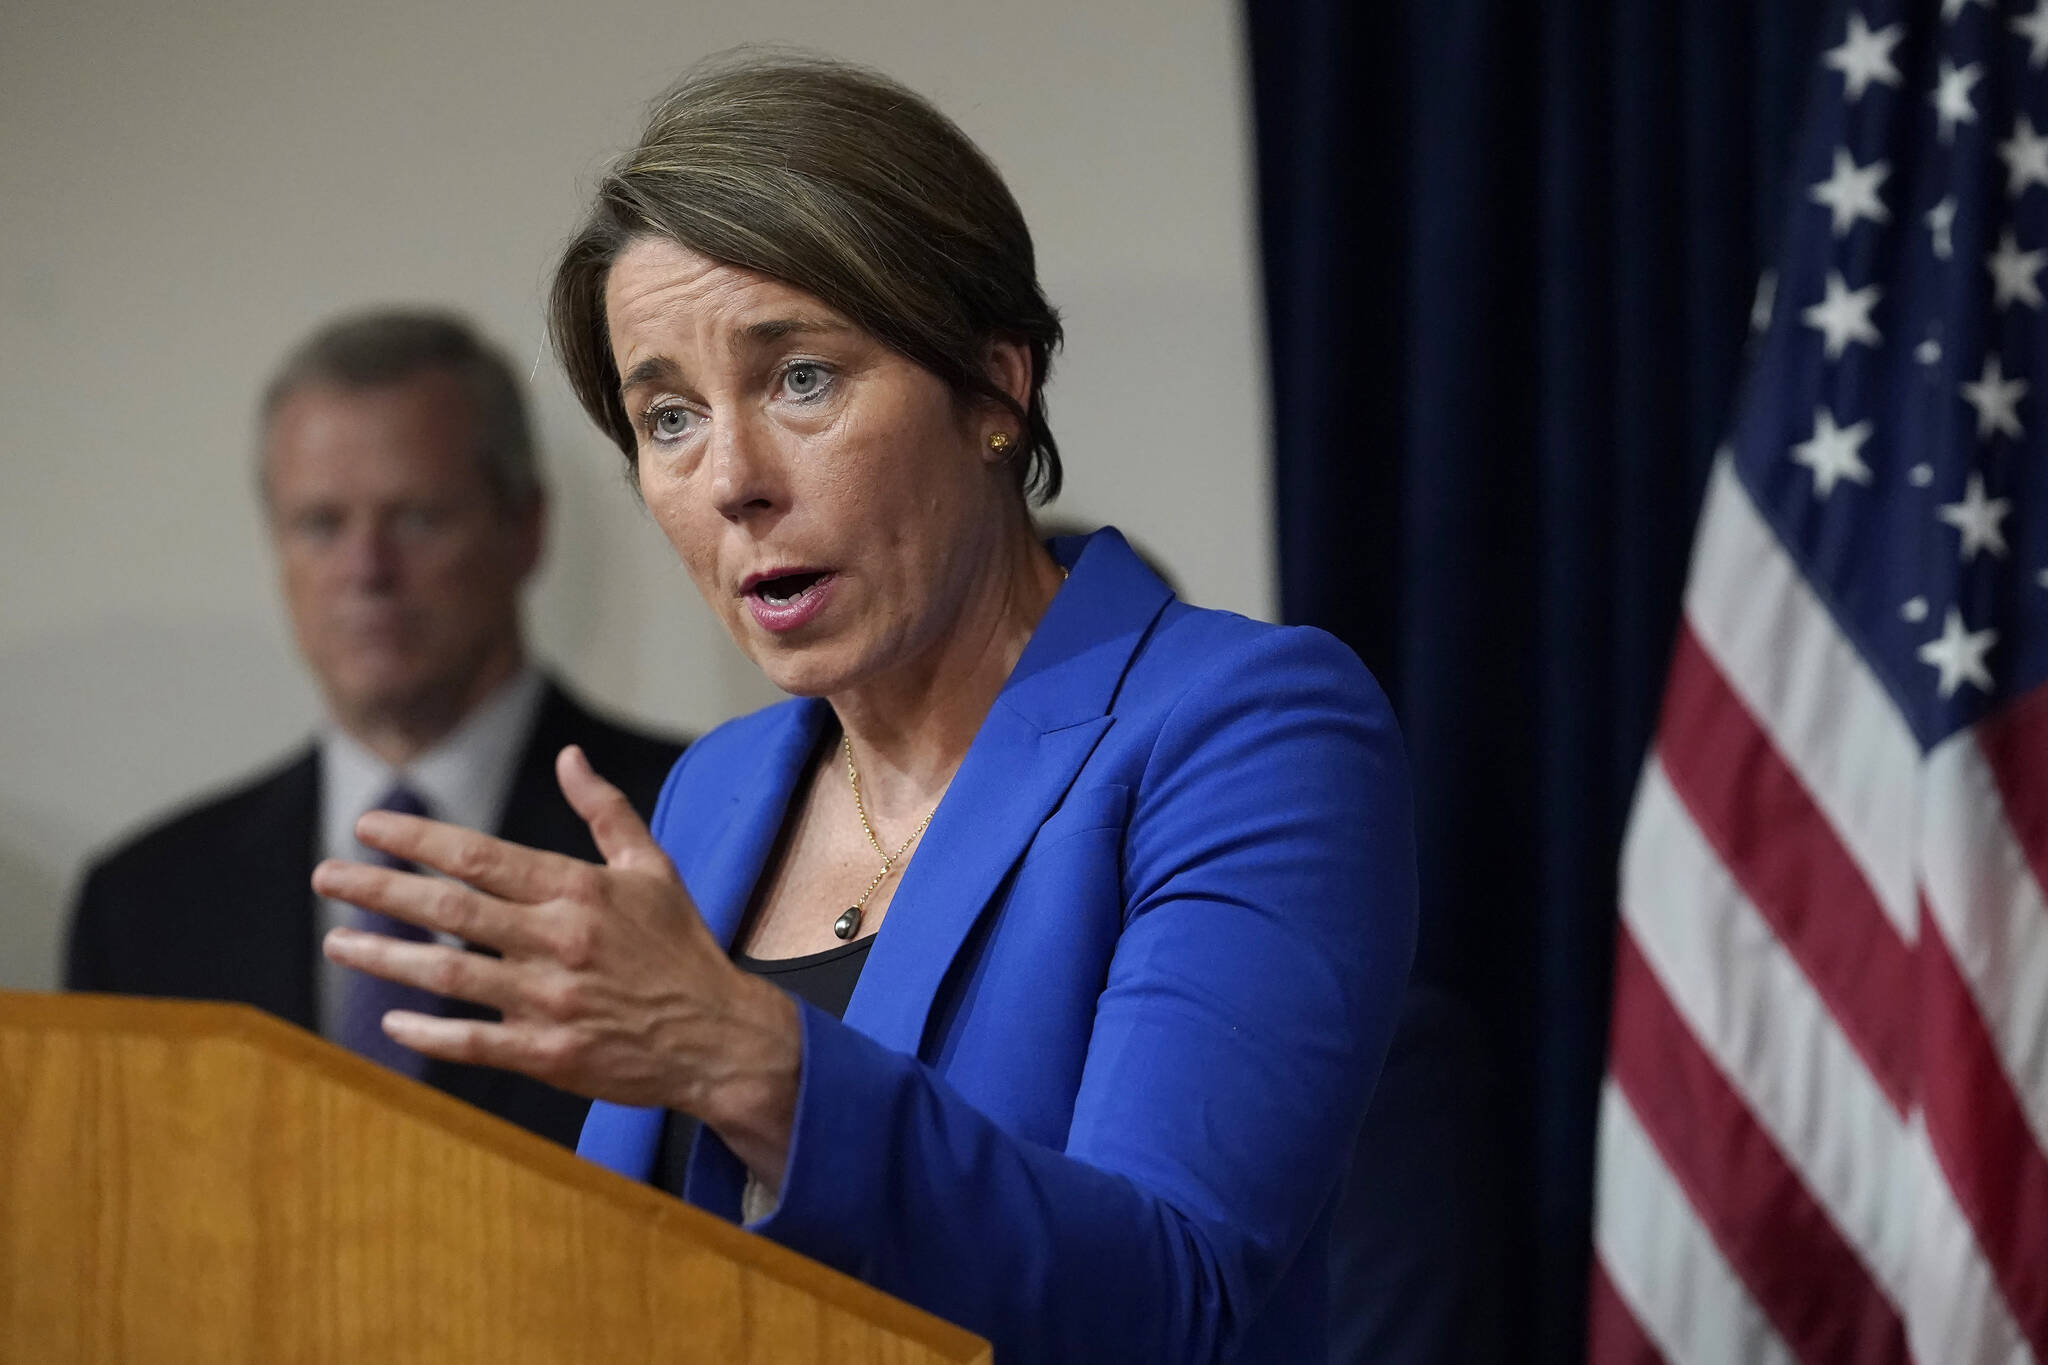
846, 530, 1171, 1054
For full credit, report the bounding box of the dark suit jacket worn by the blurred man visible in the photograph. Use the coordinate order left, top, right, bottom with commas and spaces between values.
66, 681, 682, 1146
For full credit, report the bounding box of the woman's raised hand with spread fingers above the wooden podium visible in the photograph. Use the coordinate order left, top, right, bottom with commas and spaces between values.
313, 745, 803, 1187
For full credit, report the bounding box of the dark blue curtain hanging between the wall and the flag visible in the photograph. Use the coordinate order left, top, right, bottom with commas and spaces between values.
1245, 0, 1839, 1363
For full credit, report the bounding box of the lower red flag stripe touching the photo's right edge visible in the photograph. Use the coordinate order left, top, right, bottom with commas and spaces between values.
1919, 908, 2048, 1357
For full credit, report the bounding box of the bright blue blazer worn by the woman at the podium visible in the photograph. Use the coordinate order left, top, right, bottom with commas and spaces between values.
580, 530, 1415, 1365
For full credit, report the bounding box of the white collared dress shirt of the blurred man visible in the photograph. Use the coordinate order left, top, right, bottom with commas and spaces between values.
313, 665, 545, 1038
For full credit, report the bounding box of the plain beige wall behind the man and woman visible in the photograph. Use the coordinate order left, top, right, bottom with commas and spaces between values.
0, 0, 1272, 986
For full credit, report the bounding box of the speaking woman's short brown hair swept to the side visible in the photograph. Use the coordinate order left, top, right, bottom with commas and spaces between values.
549, 53, 1061, 501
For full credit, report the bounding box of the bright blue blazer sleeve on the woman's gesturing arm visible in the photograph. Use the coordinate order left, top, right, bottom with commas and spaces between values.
690, 630, 1415, 1361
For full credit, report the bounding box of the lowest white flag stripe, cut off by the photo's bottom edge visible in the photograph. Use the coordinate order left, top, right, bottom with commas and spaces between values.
1593, 1081, 1796, 1365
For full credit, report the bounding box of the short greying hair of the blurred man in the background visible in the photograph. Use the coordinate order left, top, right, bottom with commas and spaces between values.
258, 309, 541, 508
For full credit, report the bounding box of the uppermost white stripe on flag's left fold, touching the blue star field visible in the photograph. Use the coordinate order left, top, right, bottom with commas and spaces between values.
1686, 454, 1919, 941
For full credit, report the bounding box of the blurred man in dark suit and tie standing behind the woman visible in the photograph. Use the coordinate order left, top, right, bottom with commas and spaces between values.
66, 311, 680, 1144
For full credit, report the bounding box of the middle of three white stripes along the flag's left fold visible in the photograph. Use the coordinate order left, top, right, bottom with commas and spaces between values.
1622, 759, 1916, 1300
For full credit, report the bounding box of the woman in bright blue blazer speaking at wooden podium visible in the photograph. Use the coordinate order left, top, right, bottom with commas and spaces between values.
313, 59, 1415, 1361
